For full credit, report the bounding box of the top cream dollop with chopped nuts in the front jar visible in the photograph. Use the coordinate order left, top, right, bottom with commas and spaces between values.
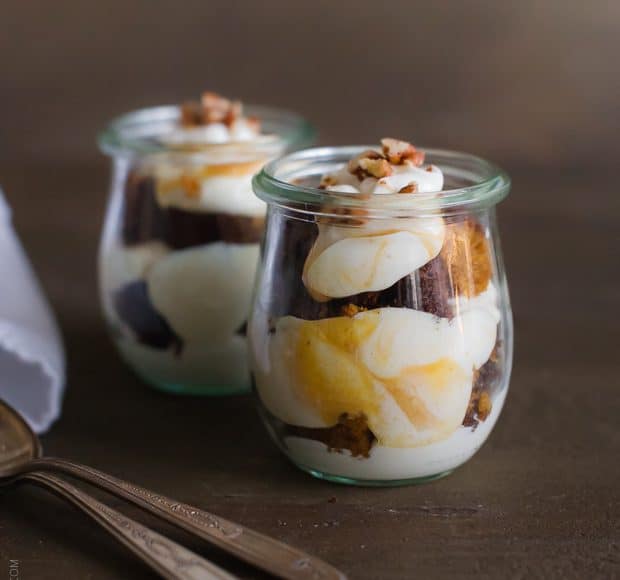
303, 139, 445, 301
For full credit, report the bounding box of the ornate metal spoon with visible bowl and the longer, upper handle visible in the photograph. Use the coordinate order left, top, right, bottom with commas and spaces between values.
0, 401, 346, 580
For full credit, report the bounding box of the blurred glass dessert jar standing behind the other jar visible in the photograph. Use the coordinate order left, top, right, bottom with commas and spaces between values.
99, 106, 313, 395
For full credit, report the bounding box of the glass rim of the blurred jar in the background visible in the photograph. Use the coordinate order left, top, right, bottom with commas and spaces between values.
97, 105, 315, 162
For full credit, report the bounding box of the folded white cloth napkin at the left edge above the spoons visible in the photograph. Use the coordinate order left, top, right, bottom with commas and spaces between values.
0, 189, 65, 433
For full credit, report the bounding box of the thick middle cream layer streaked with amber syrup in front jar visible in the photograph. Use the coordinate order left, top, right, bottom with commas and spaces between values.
250, 283, 500, 447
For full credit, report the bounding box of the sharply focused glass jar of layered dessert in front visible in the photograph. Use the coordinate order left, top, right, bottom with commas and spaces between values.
249, 147, 513, 485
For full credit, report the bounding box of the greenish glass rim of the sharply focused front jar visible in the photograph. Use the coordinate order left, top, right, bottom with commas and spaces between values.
253, 145, 510, 217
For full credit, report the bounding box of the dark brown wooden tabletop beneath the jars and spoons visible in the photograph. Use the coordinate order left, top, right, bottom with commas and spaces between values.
0, 160, 620, 580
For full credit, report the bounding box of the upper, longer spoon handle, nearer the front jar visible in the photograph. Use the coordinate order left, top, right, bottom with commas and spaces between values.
30, 457, 346, 580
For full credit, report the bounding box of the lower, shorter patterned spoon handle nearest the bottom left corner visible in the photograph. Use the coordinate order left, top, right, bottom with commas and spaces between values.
19, 472, 237, 580
